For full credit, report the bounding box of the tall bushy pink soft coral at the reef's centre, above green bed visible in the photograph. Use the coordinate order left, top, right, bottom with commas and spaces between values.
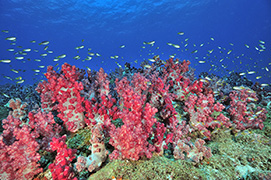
109, 74, 157, 160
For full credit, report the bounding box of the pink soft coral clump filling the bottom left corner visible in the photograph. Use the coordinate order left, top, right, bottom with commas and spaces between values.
0, 115, 42, 180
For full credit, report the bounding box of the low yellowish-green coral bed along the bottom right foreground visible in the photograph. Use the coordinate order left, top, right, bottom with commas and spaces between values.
85, 125, 271, 180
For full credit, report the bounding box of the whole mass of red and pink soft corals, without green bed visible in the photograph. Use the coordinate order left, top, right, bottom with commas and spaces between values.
0, 58, 267, 180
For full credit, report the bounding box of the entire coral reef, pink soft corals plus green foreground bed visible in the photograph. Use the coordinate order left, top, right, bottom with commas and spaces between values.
0, 56, 271, 180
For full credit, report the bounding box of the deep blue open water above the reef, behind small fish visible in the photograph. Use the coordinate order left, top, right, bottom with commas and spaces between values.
0, 0, 271, 84
